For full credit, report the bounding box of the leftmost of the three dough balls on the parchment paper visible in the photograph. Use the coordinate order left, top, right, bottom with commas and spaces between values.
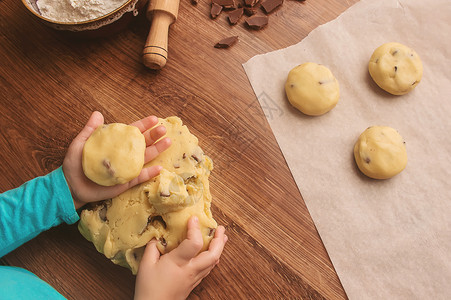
285, 62, 340, 116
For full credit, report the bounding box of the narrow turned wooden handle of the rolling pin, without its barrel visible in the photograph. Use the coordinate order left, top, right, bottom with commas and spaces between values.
143, 10, 176, 70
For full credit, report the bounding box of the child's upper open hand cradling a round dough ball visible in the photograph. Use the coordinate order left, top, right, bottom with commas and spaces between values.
63, 111, 171, 209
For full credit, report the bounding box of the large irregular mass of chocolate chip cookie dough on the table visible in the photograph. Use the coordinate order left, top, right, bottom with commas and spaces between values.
78, 117, 217, 274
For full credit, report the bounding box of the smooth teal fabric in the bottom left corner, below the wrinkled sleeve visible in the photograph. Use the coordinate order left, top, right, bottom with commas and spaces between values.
0, 266, 65, 300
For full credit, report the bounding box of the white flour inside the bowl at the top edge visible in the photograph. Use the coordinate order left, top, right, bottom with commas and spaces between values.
36, 0, 127, 22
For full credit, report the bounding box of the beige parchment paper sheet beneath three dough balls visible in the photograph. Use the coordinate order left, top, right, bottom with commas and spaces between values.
243, 0, 451, 299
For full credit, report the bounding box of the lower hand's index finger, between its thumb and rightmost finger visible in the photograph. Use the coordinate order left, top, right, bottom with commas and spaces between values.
170, 216, 204, 265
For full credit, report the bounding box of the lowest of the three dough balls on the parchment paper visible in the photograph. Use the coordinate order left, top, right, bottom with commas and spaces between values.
354, 126, 407, 179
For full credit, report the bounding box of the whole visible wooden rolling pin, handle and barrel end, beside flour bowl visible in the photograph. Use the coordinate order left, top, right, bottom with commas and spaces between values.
142, 0, 180, 70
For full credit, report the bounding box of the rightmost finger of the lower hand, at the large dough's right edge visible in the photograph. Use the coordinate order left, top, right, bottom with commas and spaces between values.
194, 226, 228, 270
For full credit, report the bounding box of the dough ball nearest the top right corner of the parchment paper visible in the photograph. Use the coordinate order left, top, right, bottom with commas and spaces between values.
368, 43, 423, 95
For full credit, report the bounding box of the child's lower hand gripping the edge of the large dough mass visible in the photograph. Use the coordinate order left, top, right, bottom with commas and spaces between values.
135, 217, 227, 300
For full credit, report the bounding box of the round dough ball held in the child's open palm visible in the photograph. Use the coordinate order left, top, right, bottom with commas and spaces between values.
82, 123, 146, 186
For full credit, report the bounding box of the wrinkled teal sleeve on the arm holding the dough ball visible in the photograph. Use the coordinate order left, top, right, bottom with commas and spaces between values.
0, 167, 79, 257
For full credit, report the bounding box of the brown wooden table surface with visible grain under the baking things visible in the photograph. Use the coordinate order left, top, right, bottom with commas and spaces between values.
0, 0, 357, 299
